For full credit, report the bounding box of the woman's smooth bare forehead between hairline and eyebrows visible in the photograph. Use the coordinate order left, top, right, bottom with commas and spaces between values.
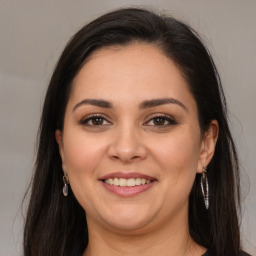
70, 43, 195, 107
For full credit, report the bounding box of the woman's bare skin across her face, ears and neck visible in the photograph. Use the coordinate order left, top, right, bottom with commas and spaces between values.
56, 44, 218, 256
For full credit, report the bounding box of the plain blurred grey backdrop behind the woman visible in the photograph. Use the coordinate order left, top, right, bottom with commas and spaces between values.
0, 0, 256, 256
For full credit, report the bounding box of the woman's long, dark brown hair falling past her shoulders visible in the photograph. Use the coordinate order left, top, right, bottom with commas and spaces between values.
24, 8, 240, 256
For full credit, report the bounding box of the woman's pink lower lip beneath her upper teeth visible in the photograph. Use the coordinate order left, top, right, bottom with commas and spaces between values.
101, 181, 156, 197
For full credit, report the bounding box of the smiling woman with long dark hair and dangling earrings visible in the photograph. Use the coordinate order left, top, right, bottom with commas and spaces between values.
24, 9, 251, 256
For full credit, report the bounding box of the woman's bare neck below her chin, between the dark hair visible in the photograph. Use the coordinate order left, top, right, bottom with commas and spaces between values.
83, 209, 206, 256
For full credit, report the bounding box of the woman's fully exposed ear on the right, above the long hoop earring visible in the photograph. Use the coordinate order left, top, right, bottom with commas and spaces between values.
197, 120, 219, 173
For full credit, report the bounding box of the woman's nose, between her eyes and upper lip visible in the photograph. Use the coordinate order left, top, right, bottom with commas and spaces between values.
108, 125, 147, 163
